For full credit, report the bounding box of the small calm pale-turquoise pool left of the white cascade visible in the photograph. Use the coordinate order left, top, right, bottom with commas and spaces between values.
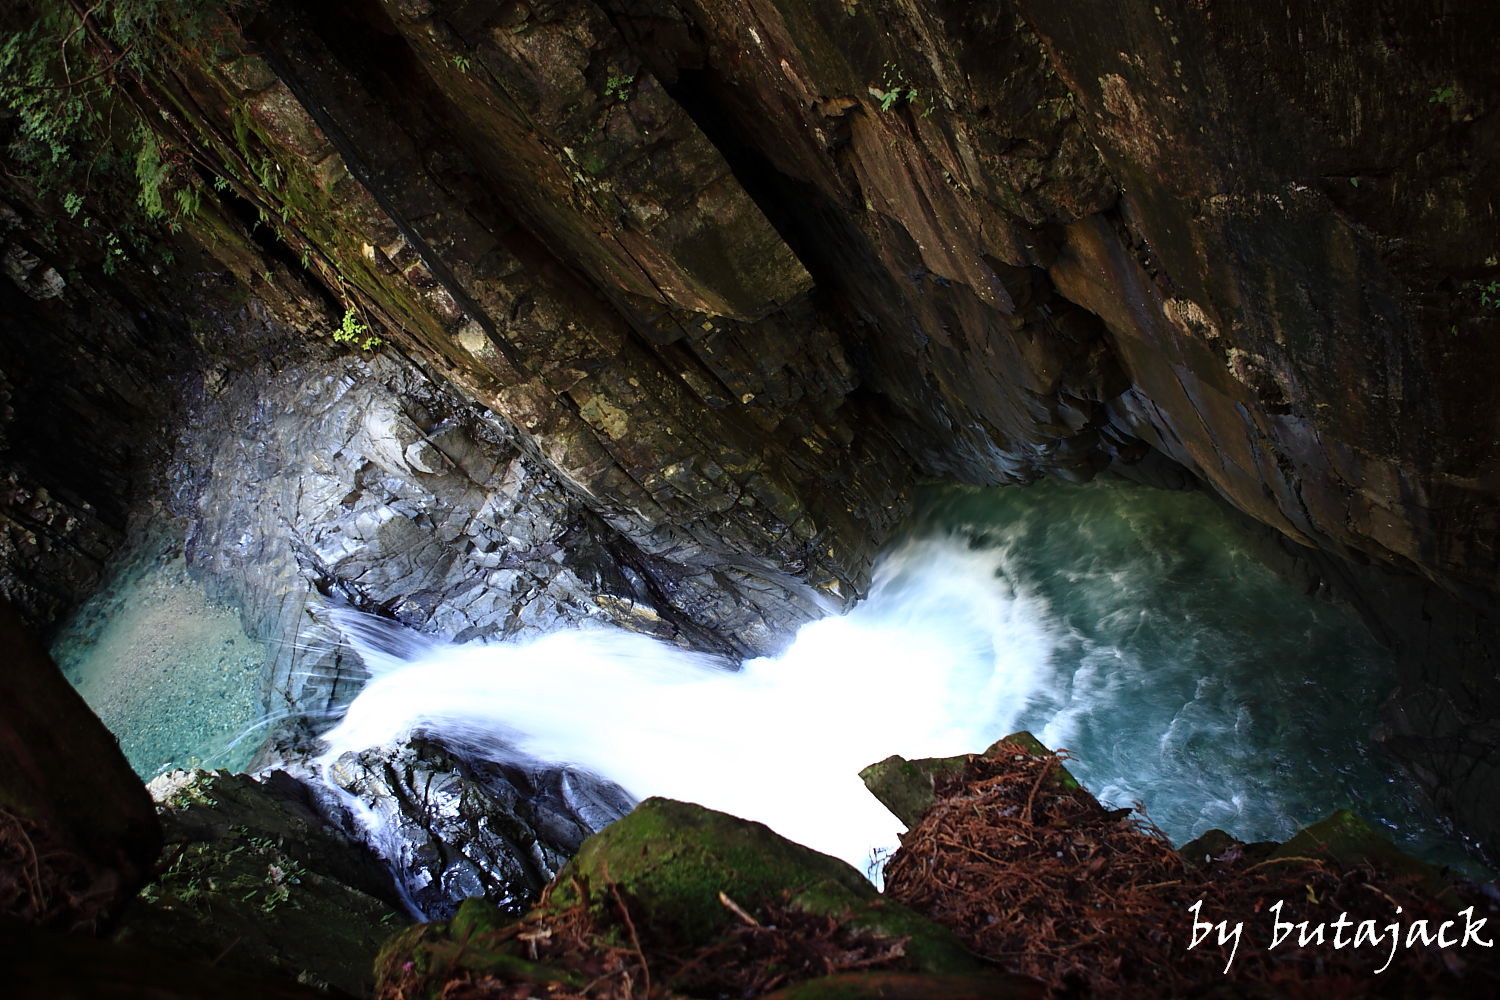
53, 543, 266, 780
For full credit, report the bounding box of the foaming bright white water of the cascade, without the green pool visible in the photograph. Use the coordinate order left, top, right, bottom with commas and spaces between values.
324, 538, 1056, 870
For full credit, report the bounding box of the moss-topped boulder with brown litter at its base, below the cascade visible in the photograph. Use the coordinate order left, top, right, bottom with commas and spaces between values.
380, 799, 1040, 999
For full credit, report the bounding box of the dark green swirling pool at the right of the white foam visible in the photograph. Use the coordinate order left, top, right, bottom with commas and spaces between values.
906, 480, 1467, 867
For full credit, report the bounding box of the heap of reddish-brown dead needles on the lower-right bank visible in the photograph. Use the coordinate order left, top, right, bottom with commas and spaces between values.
885, 745, 1500, 1000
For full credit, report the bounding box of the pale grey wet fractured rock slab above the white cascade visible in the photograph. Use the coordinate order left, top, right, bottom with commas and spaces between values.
171, 341, 828, 749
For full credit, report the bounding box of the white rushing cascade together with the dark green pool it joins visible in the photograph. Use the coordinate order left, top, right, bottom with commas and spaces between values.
316, 483, 1463, 868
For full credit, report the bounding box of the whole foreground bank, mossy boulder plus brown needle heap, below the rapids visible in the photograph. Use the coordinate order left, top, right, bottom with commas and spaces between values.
366, 733, 1500, 1000
